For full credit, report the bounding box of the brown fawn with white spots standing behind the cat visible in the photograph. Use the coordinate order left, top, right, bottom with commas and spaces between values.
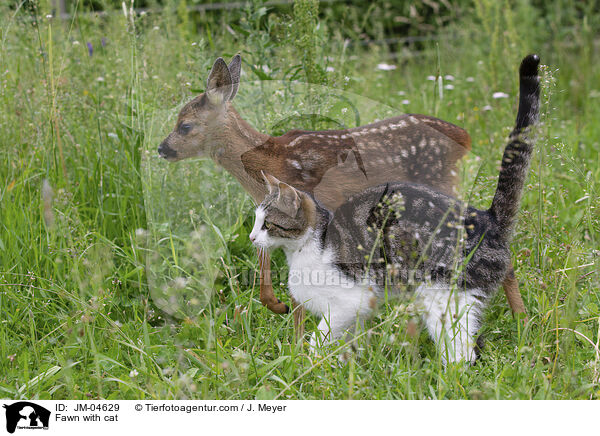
158, 54, 525, 332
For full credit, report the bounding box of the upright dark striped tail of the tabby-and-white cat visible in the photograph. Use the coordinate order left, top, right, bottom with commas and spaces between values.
489, 54, 540, 239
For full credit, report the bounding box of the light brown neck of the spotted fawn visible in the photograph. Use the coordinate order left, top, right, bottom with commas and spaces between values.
213, 106, 271, 204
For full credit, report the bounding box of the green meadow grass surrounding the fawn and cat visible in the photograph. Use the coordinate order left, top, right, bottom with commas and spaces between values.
0, 0, 600, 399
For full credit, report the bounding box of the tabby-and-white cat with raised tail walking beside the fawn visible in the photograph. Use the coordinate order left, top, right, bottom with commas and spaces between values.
250, 55, 540, 365
